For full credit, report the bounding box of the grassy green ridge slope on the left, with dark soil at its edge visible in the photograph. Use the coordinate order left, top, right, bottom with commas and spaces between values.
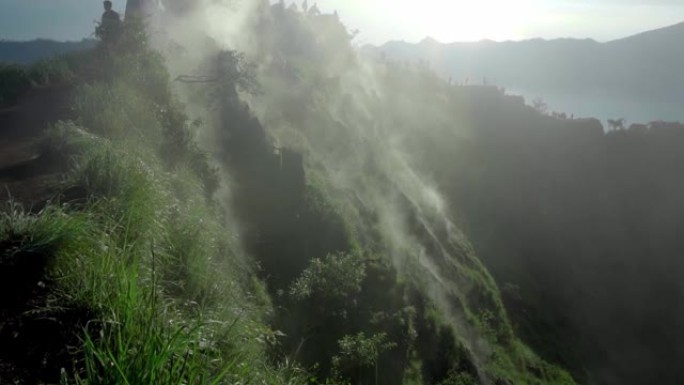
0, 24, 280, 384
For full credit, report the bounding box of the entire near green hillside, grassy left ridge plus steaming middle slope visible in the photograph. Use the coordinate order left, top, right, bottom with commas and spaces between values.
0, 1, 574, 385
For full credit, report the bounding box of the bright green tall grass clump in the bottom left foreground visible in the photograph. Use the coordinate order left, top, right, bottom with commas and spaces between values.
63, 237, 235, 384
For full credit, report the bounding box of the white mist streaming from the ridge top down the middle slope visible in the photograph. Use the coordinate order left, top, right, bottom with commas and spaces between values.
155, 2, 501, 383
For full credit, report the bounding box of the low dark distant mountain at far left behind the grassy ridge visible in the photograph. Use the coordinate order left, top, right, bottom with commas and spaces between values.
0, 39, 96, 64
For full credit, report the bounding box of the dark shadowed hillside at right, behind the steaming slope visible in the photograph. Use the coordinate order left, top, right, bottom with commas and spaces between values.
388, 82, 684, 384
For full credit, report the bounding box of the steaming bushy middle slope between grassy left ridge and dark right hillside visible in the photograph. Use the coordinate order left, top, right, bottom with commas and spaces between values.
211, 4, 574, 384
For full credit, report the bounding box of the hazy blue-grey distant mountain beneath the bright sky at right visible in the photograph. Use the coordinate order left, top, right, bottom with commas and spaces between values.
363, 23, 684, 119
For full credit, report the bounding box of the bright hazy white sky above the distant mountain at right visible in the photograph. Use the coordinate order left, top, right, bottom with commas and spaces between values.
320, 0, 684, 43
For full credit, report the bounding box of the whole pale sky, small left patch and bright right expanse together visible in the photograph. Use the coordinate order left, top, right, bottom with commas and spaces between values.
0, 0, 684, 44
